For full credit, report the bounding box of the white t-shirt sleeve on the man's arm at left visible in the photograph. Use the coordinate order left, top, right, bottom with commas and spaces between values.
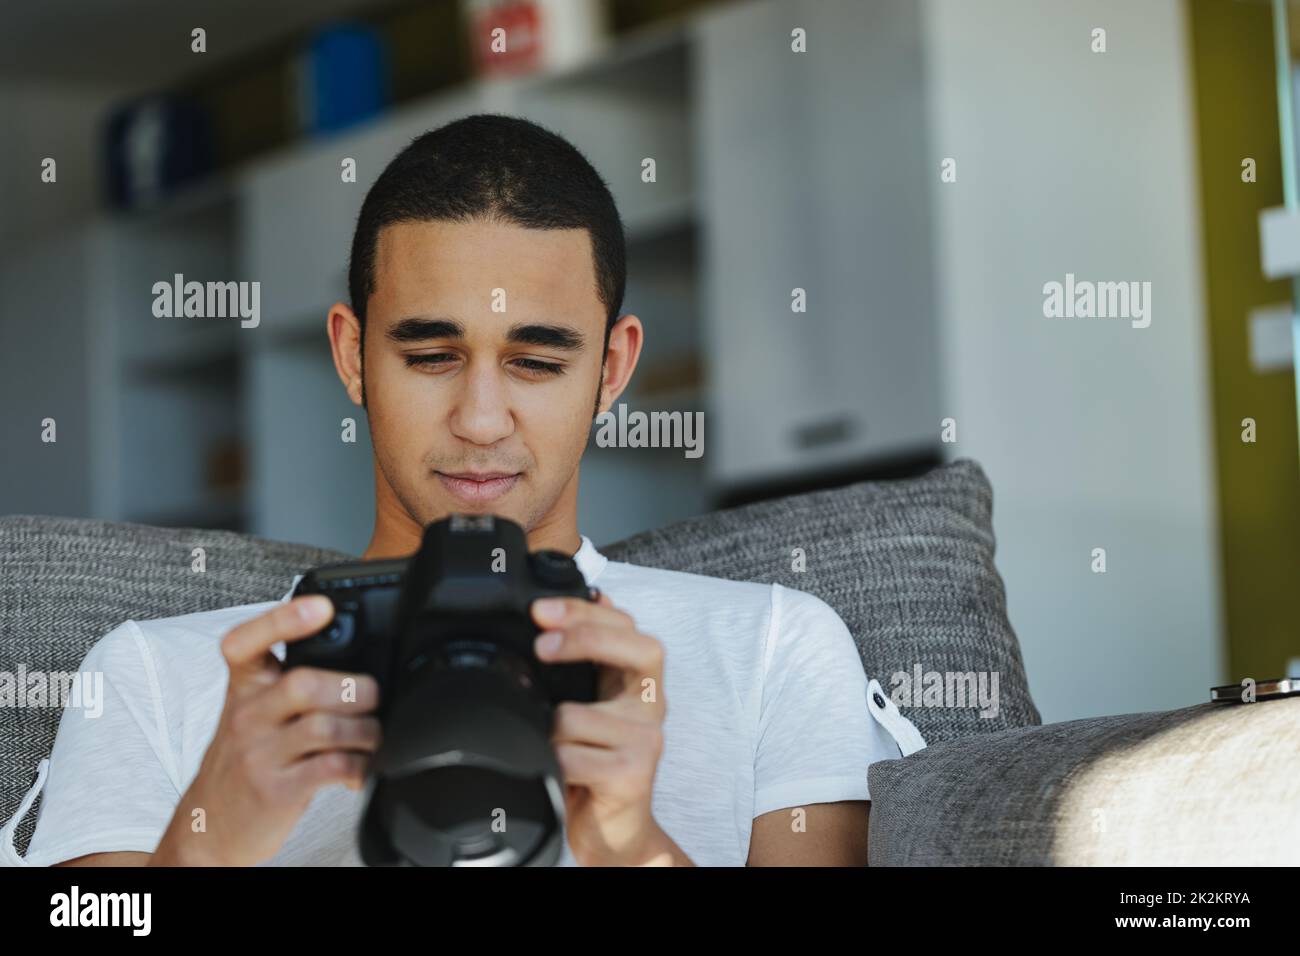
7, 620, 181, 866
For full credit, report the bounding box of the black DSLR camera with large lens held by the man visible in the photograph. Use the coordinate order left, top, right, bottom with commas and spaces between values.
285, 515, 597, 866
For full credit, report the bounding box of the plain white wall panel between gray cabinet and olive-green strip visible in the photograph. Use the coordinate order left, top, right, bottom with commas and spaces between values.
926, 0, 1223, 722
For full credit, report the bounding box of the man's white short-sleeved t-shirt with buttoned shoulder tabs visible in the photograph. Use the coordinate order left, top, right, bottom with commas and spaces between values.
0, 536, 924, 866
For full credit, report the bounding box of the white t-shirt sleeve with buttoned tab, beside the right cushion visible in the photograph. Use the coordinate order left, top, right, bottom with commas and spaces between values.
754, 584, 901, 817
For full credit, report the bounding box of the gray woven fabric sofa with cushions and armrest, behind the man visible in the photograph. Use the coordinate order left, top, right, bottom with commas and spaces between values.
0, 459, 1300, 865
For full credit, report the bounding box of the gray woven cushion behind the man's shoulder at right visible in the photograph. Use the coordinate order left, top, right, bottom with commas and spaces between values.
602, 459, 1041, 744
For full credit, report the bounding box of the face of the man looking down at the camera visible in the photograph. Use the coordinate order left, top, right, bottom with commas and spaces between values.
363, 221, 606, 532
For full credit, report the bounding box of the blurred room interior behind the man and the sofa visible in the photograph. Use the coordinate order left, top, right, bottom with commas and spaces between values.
0, 0, 1300, 722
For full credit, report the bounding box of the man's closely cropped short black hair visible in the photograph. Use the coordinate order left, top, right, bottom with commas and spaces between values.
347, 113, 628, 355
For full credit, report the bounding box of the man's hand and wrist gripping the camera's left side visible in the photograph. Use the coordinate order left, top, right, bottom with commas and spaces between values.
150, 594, 380, 866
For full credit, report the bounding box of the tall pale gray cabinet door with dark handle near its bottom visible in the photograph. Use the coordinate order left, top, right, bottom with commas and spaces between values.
696, 0, 940, 486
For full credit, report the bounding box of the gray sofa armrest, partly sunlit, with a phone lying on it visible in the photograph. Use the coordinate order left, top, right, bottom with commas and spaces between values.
868, 697, 1300, 866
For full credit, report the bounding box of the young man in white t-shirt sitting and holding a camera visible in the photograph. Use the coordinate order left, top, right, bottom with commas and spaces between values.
0, 116, 915, 866
